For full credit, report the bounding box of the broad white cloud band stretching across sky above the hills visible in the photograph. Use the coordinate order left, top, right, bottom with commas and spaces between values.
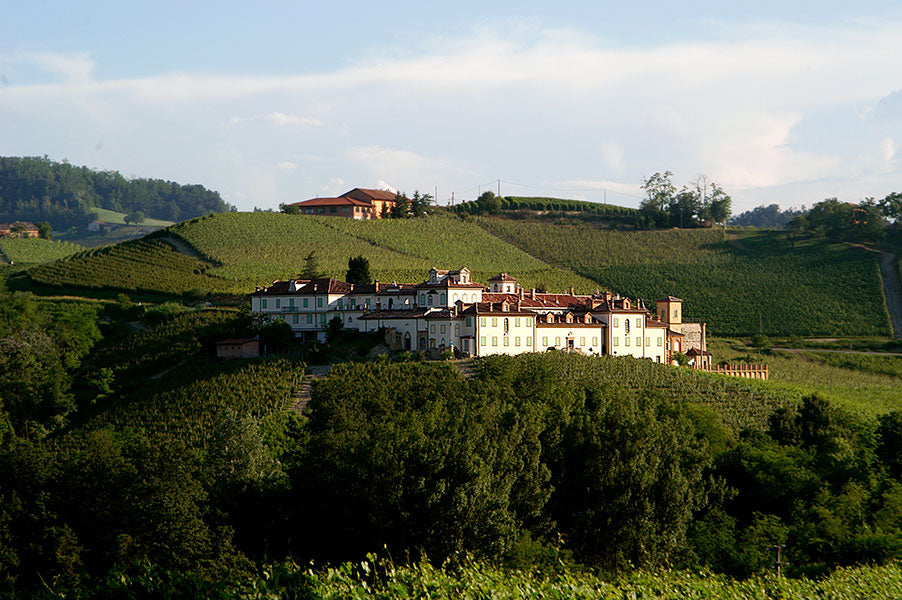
0, 20, 902, 208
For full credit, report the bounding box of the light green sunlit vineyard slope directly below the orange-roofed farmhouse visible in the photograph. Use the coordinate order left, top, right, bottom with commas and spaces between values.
171, 213, 596, 291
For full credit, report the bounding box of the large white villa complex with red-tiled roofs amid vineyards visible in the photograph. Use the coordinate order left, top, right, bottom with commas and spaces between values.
251, 268, 710, 362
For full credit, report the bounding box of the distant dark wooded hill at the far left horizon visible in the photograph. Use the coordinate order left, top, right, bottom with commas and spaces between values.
0, 156, 237, 231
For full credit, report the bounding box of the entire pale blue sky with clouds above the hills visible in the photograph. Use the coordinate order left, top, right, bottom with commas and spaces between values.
0, 0, 902, 214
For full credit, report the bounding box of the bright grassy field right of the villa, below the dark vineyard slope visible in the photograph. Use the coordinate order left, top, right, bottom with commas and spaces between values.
708, 339, 902, 415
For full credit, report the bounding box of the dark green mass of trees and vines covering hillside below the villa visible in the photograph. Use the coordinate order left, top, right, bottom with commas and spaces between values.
0, 293, 902, 597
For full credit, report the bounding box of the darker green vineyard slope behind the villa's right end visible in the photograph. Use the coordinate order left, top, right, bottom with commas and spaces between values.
479, 218, 890, 336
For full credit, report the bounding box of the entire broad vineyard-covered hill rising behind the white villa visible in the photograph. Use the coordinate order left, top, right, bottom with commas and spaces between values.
11, 213, 891, 336
